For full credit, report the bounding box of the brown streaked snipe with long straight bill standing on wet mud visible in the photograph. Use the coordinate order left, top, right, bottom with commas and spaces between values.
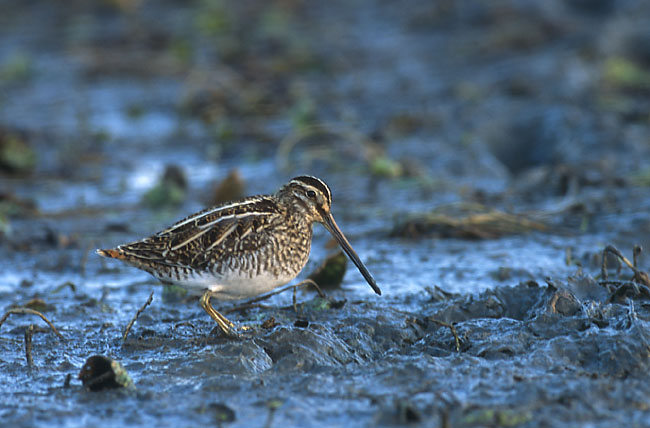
97, 176, 381, 335
